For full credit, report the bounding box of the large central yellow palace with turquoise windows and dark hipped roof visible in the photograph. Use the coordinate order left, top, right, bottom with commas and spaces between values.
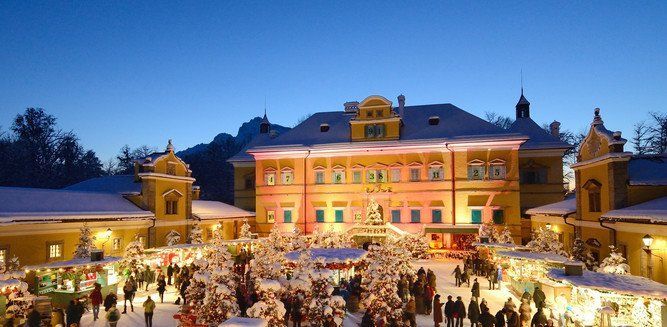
229, 92, 570, 248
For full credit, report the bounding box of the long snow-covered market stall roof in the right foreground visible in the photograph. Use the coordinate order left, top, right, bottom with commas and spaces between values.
547, 268, 667, 299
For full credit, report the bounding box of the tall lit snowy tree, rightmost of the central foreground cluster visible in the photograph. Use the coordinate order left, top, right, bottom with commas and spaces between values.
362, 242, 407, 321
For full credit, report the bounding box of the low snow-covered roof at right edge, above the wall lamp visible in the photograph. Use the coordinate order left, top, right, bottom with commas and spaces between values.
602, 196, 667, 224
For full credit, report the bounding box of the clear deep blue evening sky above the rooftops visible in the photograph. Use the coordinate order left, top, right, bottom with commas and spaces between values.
0, 1, 667, 160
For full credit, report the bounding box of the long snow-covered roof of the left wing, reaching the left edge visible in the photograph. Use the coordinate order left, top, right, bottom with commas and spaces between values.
0, 187, 155, 223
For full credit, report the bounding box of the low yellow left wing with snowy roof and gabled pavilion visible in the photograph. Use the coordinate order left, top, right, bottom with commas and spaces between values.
0, 141, 254, 267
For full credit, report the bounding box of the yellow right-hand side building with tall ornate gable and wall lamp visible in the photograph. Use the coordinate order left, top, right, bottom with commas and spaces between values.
527, 109, 667, 283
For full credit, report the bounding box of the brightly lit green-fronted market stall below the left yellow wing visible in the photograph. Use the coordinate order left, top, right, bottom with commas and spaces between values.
25, 257, 121, 308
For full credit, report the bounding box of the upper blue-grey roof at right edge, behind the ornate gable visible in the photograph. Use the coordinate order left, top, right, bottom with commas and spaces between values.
628, 154, 667, 185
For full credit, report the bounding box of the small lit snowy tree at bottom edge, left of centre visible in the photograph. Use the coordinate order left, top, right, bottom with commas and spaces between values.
248, 279, 286, 326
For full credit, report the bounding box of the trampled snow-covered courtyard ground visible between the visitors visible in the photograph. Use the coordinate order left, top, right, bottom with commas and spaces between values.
81, 260, 534, 327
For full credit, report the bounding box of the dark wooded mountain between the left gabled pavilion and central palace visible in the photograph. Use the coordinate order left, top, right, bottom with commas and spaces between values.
176, 117, 290, 204
